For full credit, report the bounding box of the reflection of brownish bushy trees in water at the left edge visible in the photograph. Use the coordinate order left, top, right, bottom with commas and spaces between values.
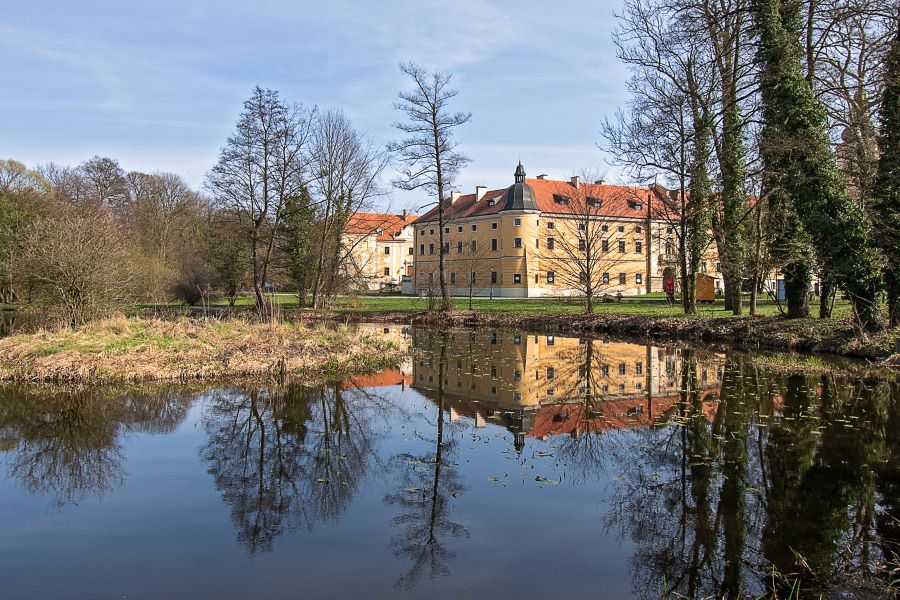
0, 386, 190, 505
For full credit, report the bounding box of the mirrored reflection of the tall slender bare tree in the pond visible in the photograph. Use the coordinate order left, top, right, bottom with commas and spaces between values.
385, 334, 467, 589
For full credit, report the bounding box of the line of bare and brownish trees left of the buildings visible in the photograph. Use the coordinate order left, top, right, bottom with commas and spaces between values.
0, 88, 387, 324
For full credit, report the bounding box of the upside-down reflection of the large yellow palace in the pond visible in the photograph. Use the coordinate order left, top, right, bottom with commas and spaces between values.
412, 329, 721, 450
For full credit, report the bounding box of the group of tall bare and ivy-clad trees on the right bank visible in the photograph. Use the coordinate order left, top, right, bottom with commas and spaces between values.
602, 0, 900, 327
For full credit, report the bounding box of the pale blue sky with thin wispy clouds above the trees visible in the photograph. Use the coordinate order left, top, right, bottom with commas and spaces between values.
0, 0, 627, 211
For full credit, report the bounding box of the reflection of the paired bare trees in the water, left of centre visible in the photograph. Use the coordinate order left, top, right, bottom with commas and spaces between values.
201, 385, 382, 554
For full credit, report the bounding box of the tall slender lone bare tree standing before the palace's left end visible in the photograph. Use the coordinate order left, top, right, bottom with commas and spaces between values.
388, 63, 472, 310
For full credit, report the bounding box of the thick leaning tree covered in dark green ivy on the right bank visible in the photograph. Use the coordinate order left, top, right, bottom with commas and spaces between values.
754, 0, 881, 326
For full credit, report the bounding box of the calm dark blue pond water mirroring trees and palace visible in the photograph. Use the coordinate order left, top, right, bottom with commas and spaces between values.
0, 325, 900, 599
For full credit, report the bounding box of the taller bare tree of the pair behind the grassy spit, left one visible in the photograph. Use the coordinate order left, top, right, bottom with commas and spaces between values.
206, 87, 311, 319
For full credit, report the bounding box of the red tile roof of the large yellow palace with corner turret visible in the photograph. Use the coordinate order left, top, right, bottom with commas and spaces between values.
417, 179, 650, 223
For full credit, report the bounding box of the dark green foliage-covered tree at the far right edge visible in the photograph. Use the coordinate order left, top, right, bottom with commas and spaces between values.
872, 25, 900, 327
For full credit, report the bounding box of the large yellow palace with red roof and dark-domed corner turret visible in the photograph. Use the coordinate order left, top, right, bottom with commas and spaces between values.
413, 163, 721, 297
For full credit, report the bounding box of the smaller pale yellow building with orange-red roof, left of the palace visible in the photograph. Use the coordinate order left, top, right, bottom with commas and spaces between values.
343, 211, 416, 290
